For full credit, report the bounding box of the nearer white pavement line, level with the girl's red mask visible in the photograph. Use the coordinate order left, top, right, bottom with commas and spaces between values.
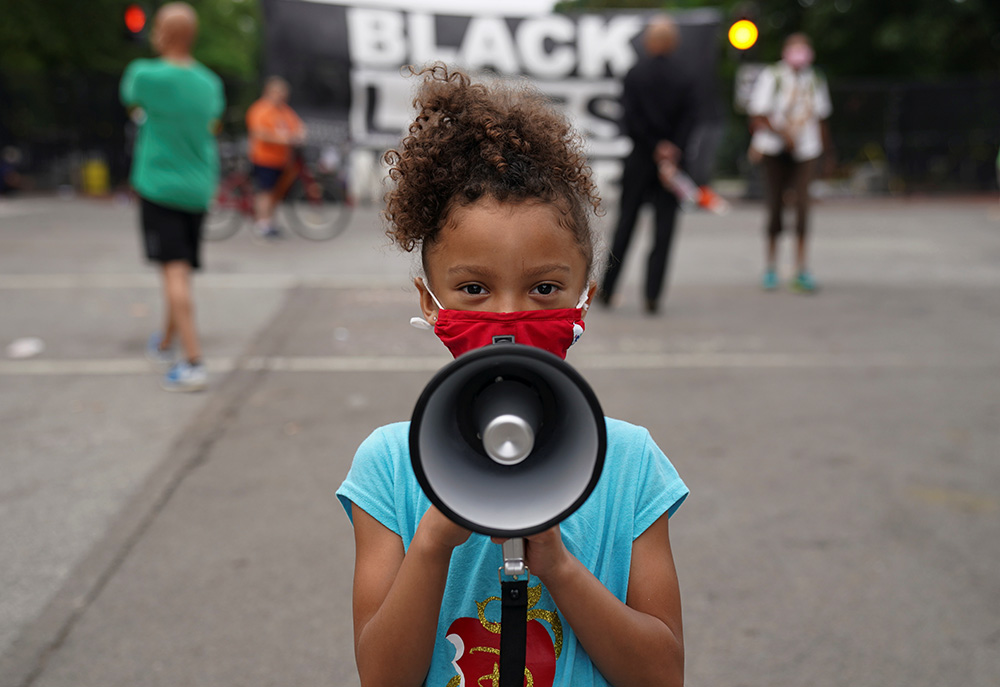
0, 353, 994, 376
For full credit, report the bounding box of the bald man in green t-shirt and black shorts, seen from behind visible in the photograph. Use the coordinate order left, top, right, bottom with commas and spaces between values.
121, 2, 225, 391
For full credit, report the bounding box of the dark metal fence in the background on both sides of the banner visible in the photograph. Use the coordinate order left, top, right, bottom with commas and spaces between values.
0, 74, 1000, 194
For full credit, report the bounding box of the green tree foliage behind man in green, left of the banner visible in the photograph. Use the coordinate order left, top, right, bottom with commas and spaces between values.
0, 0, 260, 148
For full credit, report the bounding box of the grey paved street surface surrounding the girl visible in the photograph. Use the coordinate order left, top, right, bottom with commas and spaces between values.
0, 198, 1000, 687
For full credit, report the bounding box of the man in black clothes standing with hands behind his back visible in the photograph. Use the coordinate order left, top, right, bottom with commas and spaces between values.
600, 15, 697, 314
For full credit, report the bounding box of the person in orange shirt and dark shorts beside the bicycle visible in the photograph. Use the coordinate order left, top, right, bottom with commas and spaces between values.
247, 76, 306, 239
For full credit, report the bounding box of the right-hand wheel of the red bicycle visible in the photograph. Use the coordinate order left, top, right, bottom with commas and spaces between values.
282, 175, 353, 241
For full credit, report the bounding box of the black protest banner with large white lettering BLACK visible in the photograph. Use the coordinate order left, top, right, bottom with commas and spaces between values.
263, 0, 721, 200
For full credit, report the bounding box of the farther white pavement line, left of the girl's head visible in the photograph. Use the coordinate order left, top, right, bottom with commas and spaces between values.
0, 272, 410, 291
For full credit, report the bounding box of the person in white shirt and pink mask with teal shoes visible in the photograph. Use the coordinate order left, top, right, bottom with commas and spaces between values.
747, 33, 833, 293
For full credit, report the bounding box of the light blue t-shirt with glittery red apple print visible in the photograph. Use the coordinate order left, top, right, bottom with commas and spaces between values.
337, 418, 688, 687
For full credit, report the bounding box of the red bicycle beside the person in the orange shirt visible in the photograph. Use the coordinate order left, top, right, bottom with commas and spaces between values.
204, 148, 354, 241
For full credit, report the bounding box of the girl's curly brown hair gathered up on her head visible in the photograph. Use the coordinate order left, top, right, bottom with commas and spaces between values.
383, 63, 600, 270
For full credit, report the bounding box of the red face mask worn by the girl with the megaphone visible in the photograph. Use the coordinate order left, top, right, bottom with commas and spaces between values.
410, 289, 587, 360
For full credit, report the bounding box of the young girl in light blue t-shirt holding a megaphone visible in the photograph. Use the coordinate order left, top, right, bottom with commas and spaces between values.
337, 65, 688, 687
